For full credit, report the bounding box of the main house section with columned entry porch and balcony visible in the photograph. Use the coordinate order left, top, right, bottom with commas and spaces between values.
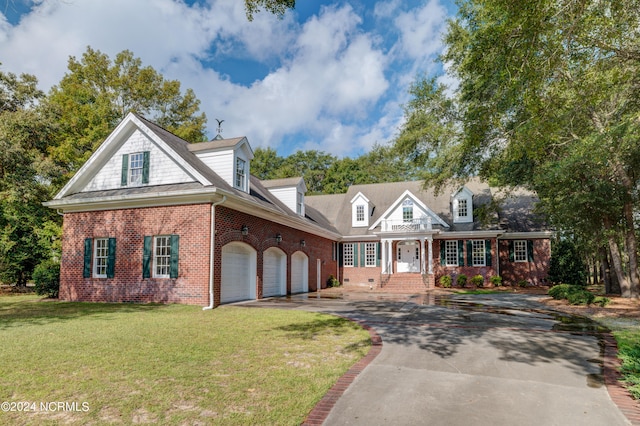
307, 179, 552, 291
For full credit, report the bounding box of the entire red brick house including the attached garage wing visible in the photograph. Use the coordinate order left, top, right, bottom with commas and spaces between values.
45, 113, 550, 308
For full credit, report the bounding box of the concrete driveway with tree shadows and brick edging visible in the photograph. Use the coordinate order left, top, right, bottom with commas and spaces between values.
251, 293, 630, 426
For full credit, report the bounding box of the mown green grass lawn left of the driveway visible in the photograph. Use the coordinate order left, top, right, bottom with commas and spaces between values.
0, 296, 370, 425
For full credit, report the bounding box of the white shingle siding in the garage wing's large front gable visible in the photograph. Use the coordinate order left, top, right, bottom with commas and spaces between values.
83, 130, 196, 191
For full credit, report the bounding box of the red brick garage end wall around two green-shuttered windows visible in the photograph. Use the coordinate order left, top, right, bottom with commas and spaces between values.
60, 204, 210, 305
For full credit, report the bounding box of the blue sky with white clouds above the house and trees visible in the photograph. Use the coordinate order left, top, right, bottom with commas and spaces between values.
0, 0, 455, 156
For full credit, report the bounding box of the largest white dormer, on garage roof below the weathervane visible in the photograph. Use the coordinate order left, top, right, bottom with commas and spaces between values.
189, 137, 253, 193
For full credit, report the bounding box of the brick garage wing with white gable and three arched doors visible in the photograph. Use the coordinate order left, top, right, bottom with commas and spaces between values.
45, 114, 340, 308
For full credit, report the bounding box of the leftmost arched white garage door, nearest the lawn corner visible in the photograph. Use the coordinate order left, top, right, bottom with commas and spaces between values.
220, 243, 256, 303
